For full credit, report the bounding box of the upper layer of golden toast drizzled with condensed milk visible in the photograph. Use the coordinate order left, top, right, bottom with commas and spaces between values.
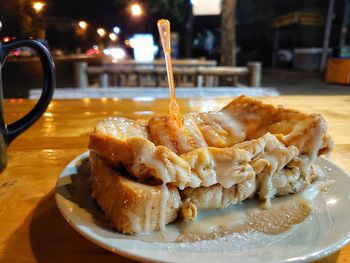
89, 96, 333, 189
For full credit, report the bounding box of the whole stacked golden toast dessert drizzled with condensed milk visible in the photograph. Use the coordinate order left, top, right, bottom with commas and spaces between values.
89, 96, 333, 234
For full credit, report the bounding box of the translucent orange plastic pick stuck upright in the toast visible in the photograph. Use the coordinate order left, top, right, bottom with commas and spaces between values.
157, 19, 181, 127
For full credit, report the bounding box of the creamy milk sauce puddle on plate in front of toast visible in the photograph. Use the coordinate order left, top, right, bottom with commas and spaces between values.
132, 186, 320, 243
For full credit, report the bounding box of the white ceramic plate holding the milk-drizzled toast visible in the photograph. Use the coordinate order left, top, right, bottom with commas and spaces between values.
55, 152, 350, 262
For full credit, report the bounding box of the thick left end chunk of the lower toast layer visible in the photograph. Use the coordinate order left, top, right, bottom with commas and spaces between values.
90, 152, 181, 234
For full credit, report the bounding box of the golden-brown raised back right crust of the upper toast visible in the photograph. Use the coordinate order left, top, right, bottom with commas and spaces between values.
221, 95, 334, 155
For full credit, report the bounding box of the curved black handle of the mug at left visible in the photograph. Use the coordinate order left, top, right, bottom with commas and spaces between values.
0, 39, 56, 145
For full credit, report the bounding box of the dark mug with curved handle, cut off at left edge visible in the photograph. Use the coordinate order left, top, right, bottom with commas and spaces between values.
0, 39, 56, 172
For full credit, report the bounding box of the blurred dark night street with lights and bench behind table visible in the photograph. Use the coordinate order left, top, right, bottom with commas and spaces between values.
0, 0, 350, 98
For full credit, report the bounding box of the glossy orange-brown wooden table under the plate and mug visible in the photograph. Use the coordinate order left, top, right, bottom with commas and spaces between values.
0, 96, 350, 262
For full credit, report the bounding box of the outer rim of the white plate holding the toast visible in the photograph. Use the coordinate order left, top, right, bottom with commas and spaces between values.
55, 151, 350, 262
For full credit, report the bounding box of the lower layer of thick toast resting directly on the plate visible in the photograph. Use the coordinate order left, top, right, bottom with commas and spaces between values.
90, 152, 320, 234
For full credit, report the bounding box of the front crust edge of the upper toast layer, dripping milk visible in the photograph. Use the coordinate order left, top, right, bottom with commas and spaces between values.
89, 127, 299, 190
